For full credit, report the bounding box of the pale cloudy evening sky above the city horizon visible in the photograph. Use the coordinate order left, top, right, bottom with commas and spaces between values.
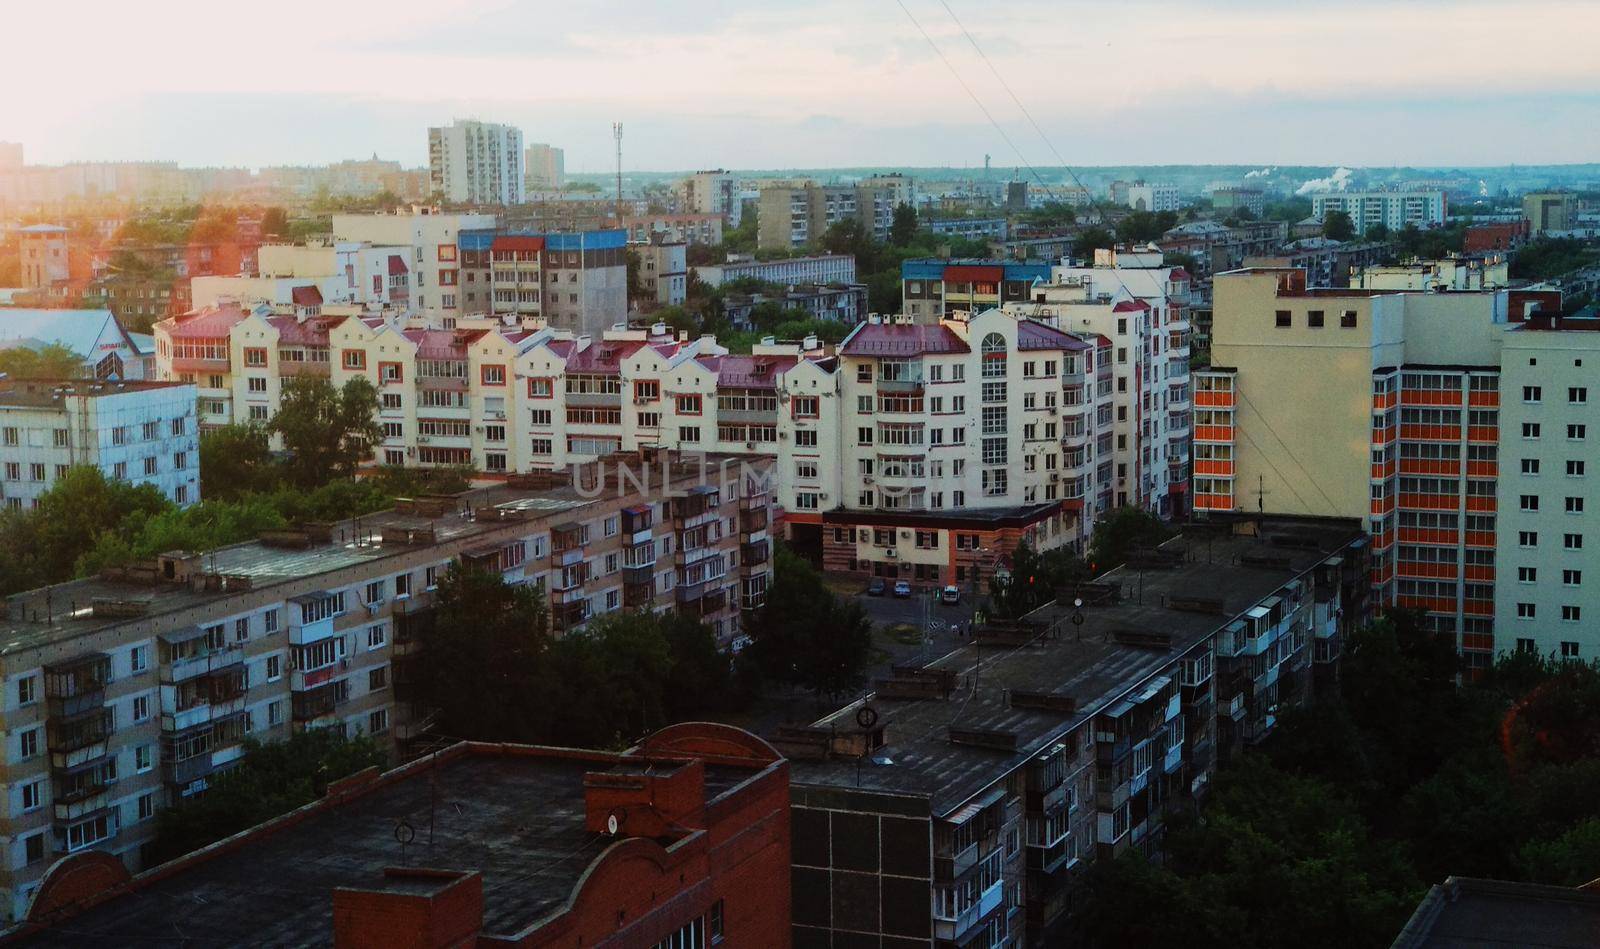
0, 0, 1600, 171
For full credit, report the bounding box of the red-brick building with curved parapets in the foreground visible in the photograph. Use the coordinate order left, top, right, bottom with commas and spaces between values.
11, 723, 790, 949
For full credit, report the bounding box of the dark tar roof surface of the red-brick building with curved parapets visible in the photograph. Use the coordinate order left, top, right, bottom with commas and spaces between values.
22, 751, 755, 947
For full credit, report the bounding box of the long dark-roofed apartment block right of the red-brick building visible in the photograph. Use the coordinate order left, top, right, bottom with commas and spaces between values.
774, 517, 1368, 947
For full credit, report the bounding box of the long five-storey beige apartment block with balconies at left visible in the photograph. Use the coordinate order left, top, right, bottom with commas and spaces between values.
0, 453, 771, 919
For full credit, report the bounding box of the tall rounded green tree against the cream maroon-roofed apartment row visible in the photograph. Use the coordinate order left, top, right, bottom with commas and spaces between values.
270, 376, 384, 487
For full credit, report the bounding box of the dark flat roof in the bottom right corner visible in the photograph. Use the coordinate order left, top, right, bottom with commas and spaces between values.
1392, 877, 1600, 949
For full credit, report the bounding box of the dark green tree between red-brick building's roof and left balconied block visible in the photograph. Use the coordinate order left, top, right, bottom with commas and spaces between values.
155, 728, 389, 863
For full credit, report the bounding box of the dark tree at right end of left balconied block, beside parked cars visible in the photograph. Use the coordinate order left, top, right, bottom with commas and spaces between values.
747, 546, 872, 699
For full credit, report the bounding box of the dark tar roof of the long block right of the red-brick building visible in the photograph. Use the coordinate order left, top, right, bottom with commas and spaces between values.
790, 520, 1360, 816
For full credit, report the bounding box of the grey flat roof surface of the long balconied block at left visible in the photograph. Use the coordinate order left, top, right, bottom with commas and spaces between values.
0, 487, 592, 655
